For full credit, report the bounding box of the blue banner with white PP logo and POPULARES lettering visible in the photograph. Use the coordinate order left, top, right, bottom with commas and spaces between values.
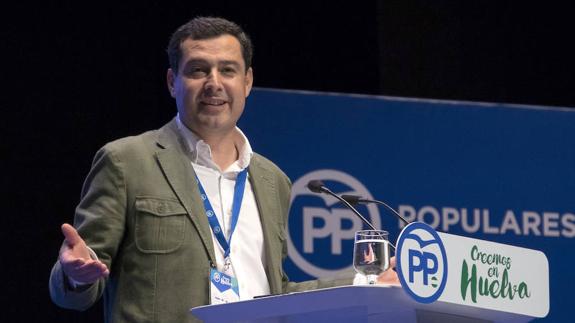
240, 88, 575, 322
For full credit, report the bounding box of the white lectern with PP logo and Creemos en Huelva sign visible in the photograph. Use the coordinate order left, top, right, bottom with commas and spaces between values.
191, 223, 549, 323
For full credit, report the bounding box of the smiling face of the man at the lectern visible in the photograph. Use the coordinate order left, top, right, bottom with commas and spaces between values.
167, 35, 253, 137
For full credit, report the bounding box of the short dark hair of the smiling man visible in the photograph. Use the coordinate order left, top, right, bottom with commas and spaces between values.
166, 17, 254, 74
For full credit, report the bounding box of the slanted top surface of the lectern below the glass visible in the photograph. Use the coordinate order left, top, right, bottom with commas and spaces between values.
191, 285, 533, 323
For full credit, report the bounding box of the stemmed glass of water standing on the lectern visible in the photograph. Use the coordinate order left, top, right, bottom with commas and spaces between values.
353, 230, 389, 285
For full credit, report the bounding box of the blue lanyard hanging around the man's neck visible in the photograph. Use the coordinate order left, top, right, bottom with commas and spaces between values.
196, 168, 248, 259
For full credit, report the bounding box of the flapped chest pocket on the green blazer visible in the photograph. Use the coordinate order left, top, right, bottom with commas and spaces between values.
135, 197, 187, 254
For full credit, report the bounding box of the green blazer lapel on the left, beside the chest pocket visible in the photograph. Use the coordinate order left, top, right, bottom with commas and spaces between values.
156, 119, 216, 265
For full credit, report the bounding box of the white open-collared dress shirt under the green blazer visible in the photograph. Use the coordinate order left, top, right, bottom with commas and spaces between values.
176, 115, 270, 300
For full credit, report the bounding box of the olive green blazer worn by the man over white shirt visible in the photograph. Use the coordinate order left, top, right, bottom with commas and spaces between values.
50, 119, 351, 322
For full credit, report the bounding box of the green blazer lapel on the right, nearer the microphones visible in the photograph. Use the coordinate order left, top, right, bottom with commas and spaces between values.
248, 155, 284, 294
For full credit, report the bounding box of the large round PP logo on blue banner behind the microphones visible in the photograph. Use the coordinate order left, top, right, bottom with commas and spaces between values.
287, 169, 380, 278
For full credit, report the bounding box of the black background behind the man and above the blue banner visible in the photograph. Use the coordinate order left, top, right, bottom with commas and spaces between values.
0, 0, 575, 322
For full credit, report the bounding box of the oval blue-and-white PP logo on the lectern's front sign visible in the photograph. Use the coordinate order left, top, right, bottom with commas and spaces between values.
396, 222, 447, 303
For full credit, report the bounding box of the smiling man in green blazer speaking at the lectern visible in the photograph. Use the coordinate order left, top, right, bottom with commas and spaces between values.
50, 17, 398, 322
